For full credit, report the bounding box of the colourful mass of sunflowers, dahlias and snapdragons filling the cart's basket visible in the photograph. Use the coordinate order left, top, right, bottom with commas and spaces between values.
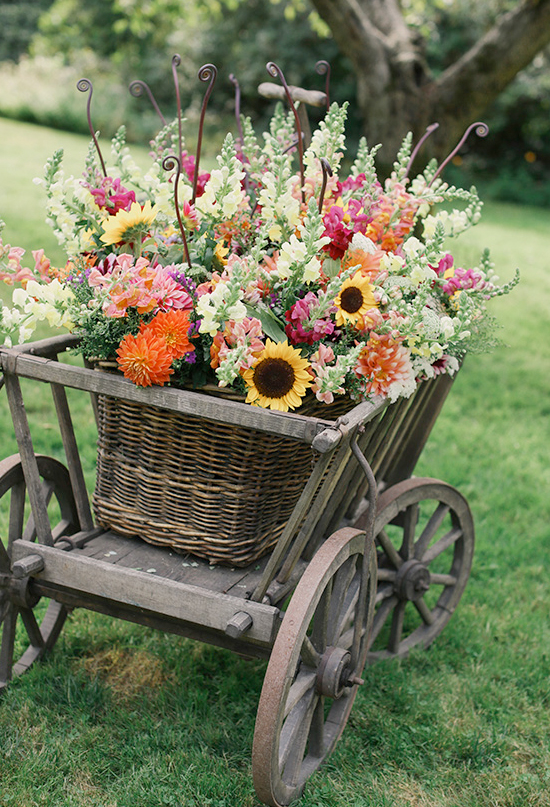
0, 64, 517, 411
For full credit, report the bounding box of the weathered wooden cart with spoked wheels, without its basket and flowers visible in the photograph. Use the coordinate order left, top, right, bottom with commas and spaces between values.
0, 337, 474, 807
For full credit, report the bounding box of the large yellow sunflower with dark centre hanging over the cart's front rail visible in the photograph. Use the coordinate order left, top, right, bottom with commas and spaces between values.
243, 339, 313, 412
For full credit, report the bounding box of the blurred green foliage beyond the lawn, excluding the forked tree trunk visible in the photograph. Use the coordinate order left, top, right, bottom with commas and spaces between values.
0, 0, 550, 205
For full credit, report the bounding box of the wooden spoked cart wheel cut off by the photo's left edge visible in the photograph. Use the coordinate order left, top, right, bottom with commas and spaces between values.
0, 455, 79, 691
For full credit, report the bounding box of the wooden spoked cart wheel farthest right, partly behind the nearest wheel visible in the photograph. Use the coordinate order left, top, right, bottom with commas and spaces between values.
368, 479, 474, 662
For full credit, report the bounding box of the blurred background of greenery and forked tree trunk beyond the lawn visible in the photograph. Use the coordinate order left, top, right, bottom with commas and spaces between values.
0, 0, 550, 204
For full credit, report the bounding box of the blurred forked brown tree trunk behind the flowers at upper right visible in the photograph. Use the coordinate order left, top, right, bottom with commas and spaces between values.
311, 0, 550, 171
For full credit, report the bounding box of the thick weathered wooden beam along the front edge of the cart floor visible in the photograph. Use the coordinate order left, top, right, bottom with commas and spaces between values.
13, 541, 279, 642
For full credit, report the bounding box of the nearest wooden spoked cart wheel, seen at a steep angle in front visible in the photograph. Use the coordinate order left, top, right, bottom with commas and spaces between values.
252, 528, 376, 807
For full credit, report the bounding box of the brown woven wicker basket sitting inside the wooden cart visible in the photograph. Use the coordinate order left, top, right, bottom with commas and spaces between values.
94, 386, 351, 566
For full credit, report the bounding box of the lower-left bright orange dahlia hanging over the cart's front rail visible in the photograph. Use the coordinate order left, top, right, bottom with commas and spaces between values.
117, 332, 174, 387
